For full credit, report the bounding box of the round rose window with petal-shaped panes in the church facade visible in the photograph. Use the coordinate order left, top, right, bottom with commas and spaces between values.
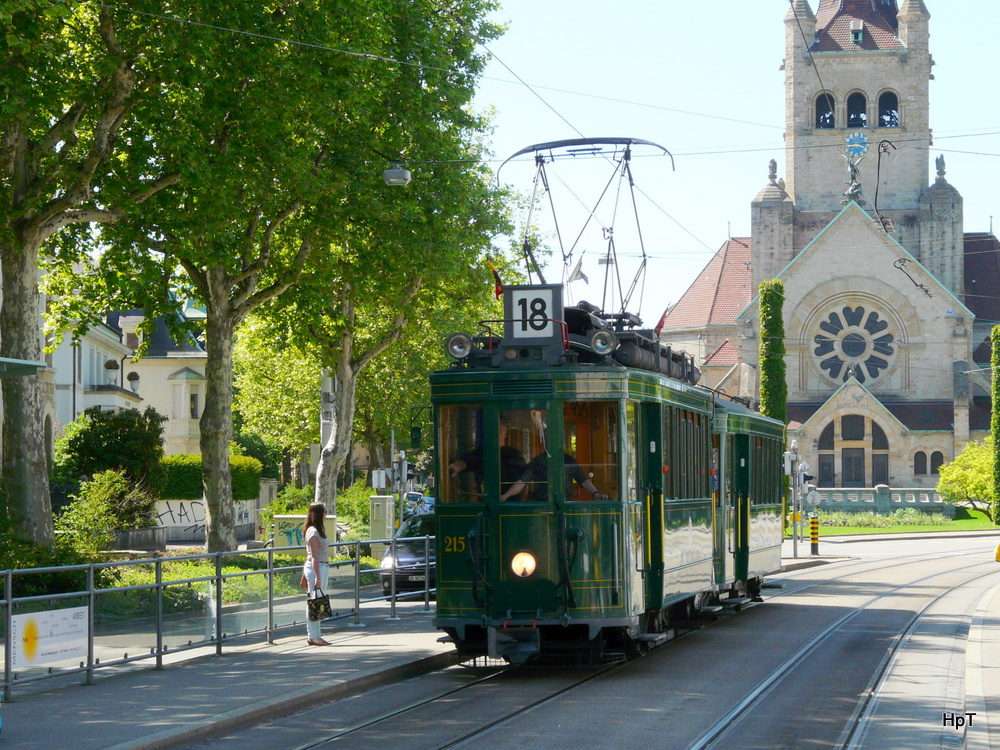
813, 305, 896, 383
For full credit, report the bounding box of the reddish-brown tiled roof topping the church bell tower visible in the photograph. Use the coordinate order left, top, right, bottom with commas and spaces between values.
809, 0, 904, 52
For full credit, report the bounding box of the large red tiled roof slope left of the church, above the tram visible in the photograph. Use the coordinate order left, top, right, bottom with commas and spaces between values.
663, 237, 751, 330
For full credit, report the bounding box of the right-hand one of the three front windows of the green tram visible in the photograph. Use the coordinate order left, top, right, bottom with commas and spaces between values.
563, 401, 620, 500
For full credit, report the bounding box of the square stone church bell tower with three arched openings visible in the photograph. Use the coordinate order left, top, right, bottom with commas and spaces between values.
784, 0, 933, 219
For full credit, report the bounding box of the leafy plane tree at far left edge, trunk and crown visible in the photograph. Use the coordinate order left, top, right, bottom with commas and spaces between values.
0, 0, 187, 545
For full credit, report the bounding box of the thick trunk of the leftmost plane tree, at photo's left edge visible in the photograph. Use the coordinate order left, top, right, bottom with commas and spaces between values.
0, 240, 53, 546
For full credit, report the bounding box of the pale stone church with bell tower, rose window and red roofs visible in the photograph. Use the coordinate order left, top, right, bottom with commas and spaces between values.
660, 0, 1000, 488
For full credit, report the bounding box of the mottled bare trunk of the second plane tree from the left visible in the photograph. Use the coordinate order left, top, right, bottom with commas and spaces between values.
199, 268, 237, 552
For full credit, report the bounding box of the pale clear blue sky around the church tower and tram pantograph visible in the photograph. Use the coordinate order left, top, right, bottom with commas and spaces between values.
474, 0, 1000, 327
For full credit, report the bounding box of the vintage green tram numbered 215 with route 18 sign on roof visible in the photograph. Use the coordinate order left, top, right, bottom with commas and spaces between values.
431, 285, 784, 663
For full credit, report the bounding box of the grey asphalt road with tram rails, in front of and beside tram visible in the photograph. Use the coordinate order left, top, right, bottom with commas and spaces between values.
182, 536, 1000, 750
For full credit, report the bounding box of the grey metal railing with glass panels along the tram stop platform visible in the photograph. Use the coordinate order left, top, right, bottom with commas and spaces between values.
0, 537, 434, 701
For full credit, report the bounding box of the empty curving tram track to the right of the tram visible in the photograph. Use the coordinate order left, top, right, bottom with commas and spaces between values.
689, 553, 998, 750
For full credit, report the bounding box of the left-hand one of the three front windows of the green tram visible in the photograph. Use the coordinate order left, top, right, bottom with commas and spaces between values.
438, 404, 485, 503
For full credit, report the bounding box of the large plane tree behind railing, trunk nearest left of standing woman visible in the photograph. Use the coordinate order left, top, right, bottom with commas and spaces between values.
42, 0, 504, 551
